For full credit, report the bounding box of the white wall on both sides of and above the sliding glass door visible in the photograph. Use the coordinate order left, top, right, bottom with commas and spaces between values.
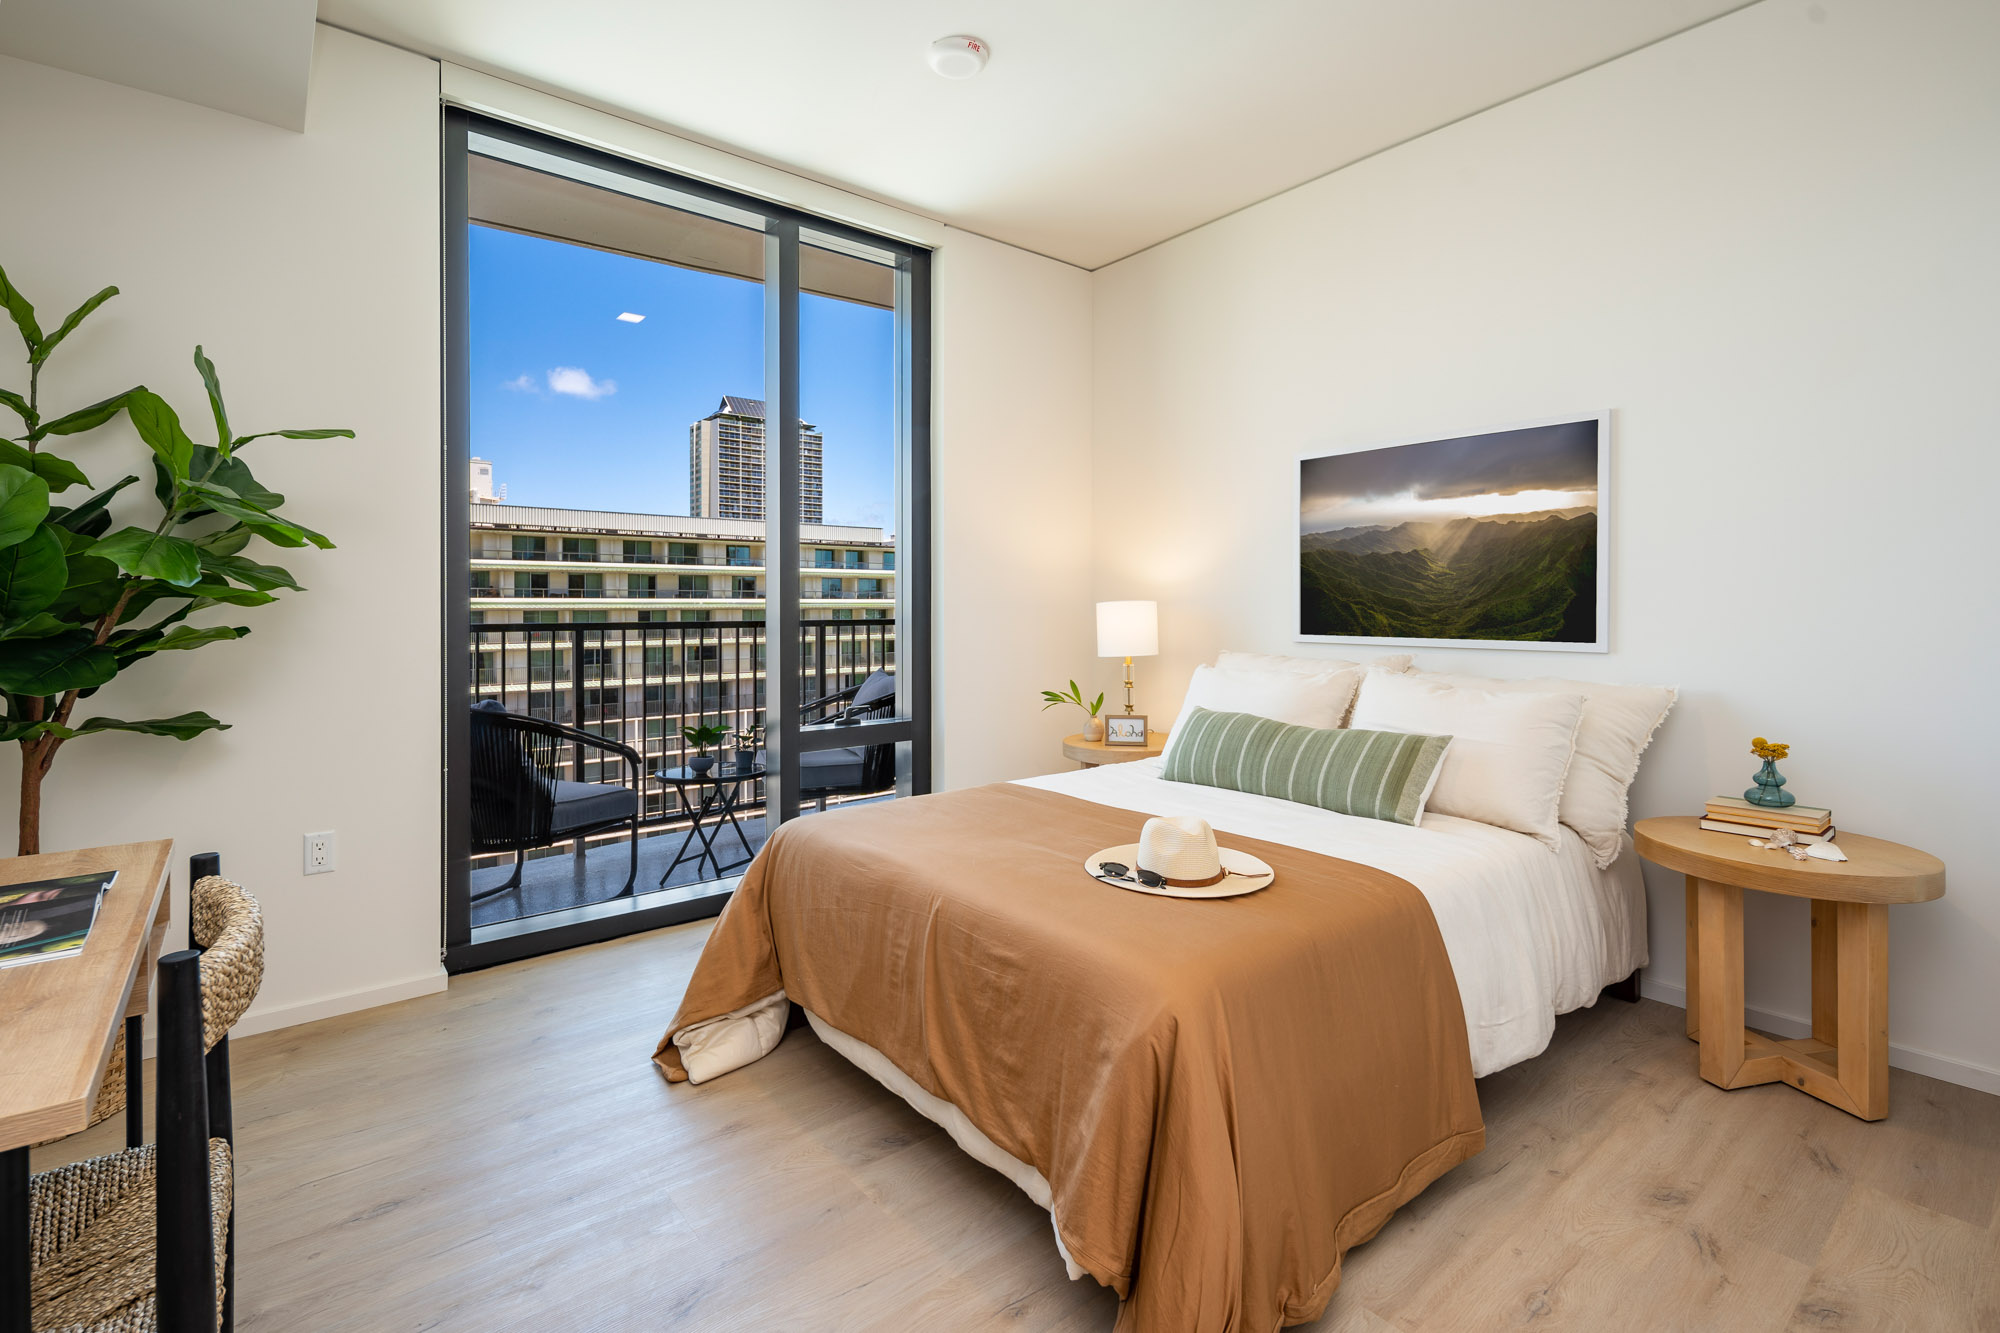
0, 28, 1090, 1031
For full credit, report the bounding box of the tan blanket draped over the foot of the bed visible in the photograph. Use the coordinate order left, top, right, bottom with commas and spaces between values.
654, 785, 1486, 1333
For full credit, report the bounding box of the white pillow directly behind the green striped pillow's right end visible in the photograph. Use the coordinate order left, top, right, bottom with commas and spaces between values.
1354, 671, 1584, 851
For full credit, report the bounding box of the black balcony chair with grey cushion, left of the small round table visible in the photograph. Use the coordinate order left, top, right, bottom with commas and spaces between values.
472, 699, 642, 903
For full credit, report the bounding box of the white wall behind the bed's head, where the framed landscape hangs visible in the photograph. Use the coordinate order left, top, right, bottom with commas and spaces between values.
1094, 0, 2000, 1091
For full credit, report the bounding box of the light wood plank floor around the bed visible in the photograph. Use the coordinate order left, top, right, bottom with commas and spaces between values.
36, 925, 2000, 1333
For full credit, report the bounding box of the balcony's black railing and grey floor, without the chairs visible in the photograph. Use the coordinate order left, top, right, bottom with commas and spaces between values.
468, 620, 896, 927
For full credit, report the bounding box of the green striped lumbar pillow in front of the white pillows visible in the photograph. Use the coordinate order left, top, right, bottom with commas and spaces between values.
1162, 709, 1452, 825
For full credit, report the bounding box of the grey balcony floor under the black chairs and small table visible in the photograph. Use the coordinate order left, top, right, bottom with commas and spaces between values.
472, 797, 888, 927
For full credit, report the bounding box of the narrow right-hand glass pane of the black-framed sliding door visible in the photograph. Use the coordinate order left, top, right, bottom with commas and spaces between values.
798, 230, 908, 813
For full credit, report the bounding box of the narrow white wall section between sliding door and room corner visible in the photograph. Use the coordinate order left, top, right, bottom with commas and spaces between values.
932, 230, 1096, 791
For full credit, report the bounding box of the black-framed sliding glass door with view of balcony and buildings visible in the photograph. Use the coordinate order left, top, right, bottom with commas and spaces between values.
444, 112, 930, 969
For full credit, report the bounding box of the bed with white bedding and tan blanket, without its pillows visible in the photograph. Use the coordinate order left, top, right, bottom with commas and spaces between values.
656, 759, 1646, 1333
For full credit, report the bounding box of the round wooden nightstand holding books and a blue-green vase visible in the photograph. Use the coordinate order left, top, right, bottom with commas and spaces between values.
1632, 815, 1944, 1121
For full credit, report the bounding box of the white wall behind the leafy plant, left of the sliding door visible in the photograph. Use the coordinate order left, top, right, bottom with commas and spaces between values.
0, 28, 442, 1025
